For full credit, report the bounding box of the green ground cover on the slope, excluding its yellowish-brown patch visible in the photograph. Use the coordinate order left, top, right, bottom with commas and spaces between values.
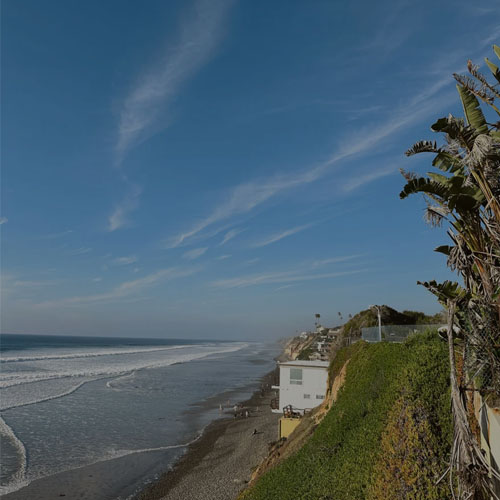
242, 334, 451, 500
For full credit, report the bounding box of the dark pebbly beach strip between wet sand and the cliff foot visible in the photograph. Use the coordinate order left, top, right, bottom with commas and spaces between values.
138, 372, 280, 500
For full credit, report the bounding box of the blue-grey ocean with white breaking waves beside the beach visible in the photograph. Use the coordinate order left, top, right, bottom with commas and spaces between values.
0, 334, 280, 500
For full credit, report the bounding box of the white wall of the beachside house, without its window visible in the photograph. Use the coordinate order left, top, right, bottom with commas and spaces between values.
279, 366, 328, 410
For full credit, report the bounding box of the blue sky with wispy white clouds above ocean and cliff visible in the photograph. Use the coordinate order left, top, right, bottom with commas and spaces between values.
0, 0, 500, 340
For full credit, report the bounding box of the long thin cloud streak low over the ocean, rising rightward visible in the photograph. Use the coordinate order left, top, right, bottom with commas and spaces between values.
36, 267, 197, 307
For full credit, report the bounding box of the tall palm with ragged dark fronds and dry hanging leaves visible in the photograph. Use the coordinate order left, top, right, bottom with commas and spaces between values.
400, 46, 500, 498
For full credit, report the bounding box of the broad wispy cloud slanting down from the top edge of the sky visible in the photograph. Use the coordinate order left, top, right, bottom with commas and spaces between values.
115, 0, 231, 163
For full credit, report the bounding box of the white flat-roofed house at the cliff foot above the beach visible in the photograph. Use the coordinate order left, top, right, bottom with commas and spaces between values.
273, 360, 329, 413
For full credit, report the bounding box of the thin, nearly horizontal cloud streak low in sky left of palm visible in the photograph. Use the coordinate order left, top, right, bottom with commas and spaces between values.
212, 269, 366, 288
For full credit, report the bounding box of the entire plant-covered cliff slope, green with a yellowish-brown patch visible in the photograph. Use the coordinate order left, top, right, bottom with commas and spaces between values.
241, 333, 452, 500
